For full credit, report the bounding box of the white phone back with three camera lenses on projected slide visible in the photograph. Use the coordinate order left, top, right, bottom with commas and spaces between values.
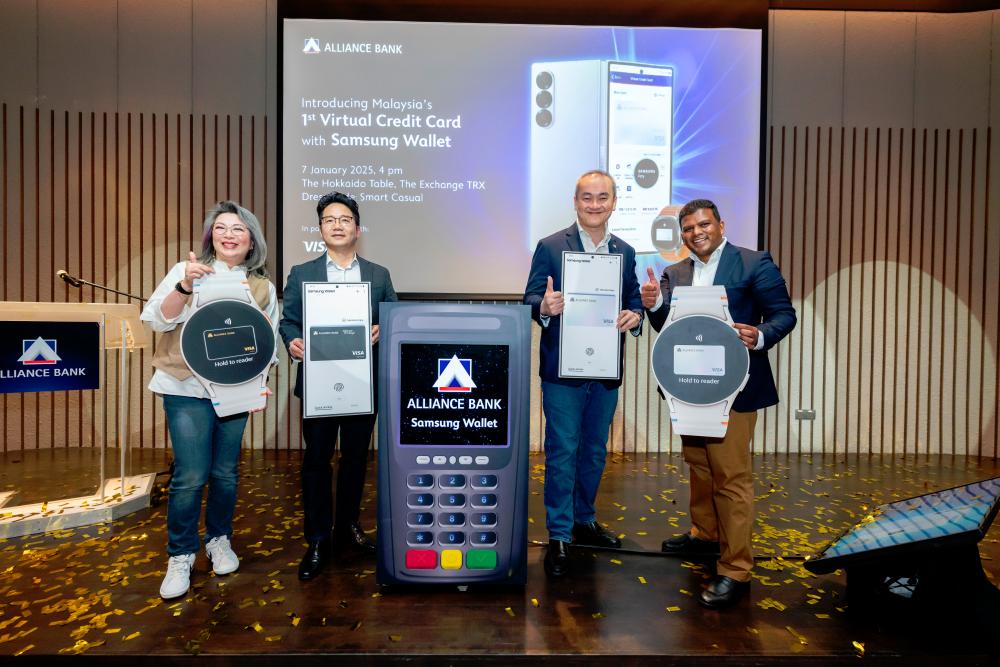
528, 60, 604, 250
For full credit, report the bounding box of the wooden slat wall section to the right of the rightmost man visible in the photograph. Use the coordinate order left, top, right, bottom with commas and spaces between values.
762, 127, 1000, 457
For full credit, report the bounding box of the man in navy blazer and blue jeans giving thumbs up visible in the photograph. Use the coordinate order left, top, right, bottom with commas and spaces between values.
524, 171, 643, 577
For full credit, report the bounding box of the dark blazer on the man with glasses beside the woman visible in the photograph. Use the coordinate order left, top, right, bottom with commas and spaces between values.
278, 252, 397, 398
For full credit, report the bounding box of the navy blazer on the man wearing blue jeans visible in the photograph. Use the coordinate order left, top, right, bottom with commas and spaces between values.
524, 222, 643, 389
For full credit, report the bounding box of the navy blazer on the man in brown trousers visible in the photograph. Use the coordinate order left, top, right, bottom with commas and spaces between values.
649, 242, 796, 412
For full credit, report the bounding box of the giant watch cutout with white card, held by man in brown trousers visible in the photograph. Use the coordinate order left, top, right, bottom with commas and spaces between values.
650, 285, 750, 438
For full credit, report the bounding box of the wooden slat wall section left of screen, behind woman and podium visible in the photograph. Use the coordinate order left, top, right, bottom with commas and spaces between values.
0, 104, 297, 451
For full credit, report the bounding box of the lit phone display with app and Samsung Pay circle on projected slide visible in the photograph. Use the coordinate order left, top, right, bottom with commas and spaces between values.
606, 61, 674, 253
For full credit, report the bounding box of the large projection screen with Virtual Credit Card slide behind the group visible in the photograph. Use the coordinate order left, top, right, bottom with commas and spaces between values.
281, 19, 762, 295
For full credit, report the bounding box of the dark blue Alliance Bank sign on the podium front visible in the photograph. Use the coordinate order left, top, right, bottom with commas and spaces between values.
0, 321, 101, 394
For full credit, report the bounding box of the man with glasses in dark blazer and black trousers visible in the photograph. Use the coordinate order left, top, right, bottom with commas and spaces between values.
278, 192, 396, 581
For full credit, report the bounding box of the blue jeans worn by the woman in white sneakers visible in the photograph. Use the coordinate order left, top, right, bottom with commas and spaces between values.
163, 394, 248, 556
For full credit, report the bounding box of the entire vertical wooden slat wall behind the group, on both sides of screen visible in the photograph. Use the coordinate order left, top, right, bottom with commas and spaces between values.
0, 104, 1000, 458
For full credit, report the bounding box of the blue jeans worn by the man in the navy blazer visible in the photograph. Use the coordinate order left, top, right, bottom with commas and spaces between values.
542, 382, 618, 542
